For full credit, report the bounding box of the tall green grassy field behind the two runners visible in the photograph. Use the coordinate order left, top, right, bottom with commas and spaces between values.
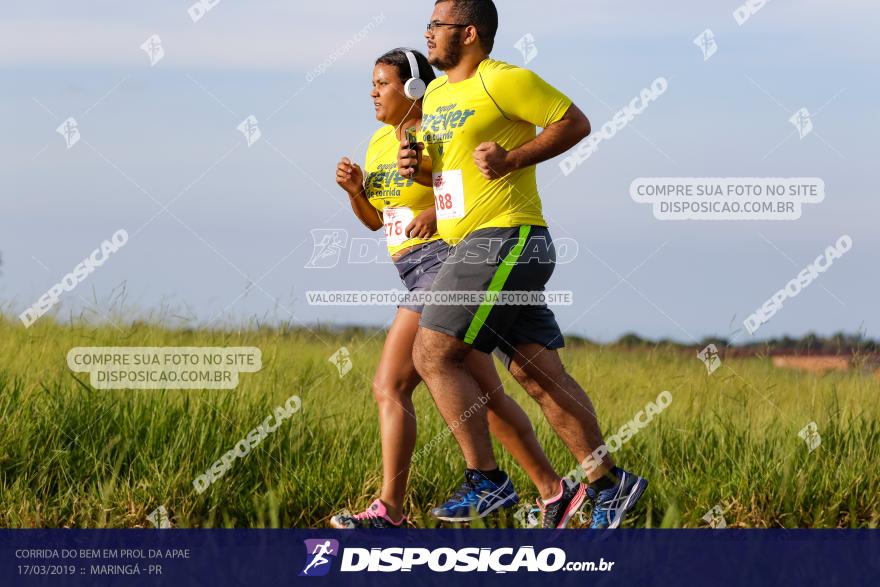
0, 319, 880, 528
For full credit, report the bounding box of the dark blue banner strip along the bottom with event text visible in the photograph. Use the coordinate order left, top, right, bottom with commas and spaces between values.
0, 529, 880, 587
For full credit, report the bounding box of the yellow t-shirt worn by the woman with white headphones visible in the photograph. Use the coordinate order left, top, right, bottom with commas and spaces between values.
364, 125, 440, 255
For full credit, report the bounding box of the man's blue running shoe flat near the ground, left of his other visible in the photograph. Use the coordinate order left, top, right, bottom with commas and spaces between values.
431, 470, 519, 522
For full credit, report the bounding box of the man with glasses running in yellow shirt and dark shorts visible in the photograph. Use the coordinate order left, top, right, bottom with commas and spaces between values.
398, 0, 647, 528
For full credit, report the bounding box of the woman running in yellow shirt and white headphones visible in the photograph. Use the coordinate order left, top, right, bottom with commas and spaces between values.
330, 49, 558, 528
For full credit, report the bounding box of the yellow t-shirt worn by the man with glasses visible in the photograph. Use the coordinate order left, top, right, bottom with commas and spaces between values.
420, 59, 571, 245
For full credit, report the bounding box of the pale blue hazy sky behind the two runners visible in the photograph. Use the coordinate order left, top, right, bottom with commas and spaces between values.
0, 0, 880, 342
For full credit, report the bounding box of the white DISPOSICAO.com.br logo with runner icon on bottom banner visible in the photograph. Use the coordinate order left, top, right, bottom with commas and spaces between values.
300, 540, 614, 577
